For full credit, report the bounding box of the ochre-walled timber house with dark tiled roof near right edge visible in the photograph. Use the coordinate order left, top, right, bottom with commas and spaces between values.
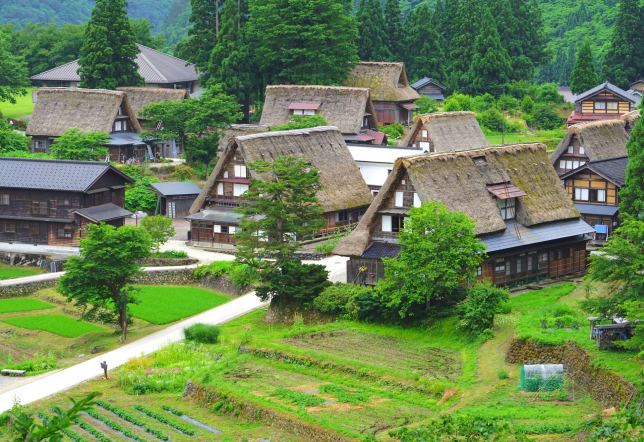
561, 155, 628, 240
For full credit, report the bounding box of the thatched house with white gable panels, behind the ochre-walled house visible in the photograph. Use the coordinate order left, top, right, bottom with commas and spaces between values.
550, 119, 629, 175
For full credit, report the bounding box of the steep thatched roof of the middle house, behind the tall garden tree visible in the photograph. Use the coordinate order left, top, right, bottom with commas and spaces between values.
190, 126, 373, 214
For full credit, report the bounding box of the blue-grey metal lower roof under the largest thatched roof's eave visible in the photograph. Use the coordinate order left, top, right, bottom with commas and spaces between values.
479, 219, 594, 253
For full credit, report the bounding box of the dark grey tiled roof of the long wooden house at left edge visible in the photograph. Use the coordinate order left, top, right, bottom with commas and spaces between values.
0, 158, 132, 192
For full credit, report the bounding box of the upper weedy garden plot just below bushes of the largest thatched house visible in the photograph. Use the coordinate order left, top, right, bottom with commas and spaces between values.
282, 329, 461, 379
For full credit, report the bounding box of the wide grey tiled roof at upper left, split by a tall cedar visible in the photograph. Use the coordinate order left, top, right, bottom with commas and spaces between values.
31, 43, 199, 84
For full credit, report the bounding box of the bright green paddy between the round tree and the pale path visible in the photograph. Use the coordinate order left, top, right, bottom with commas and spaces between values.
130, 286, 228, 324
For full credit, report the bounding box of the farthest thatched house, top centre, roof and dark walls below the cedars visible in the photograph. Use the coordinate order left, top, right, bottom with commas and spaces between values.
344, 61, 420, 125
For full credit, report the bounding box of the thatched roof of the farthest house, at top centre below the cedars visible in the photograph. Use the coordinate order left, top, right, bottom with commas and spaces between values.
344, 61, 420, 101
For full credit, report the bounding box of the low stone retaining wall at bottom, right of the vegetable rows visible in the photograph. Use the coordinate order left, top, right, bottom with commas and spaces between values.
183, 381, 352, 442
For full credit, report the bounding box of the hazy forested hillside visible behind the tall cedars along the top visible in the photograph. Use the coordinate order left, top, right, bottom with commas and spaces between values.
0, 0, 618, 85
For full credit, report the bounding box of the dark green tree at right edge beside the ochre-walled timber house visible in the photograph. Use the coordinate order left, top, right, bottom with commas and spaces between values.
619, 114, 644, 220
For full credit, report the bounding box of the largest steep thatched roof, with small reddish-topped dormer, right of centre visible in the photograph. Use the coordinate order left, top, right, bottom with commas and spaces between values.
334, 143, 579, 256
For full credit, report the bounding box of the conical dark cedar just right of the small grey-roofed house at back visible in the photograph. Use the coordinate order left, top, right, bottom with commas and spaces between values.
470, 6, 512, 97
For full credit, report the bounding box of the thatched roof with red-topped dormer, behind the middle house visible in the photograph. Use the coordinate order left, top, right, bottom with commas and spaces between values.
260, 85, 378, 134
